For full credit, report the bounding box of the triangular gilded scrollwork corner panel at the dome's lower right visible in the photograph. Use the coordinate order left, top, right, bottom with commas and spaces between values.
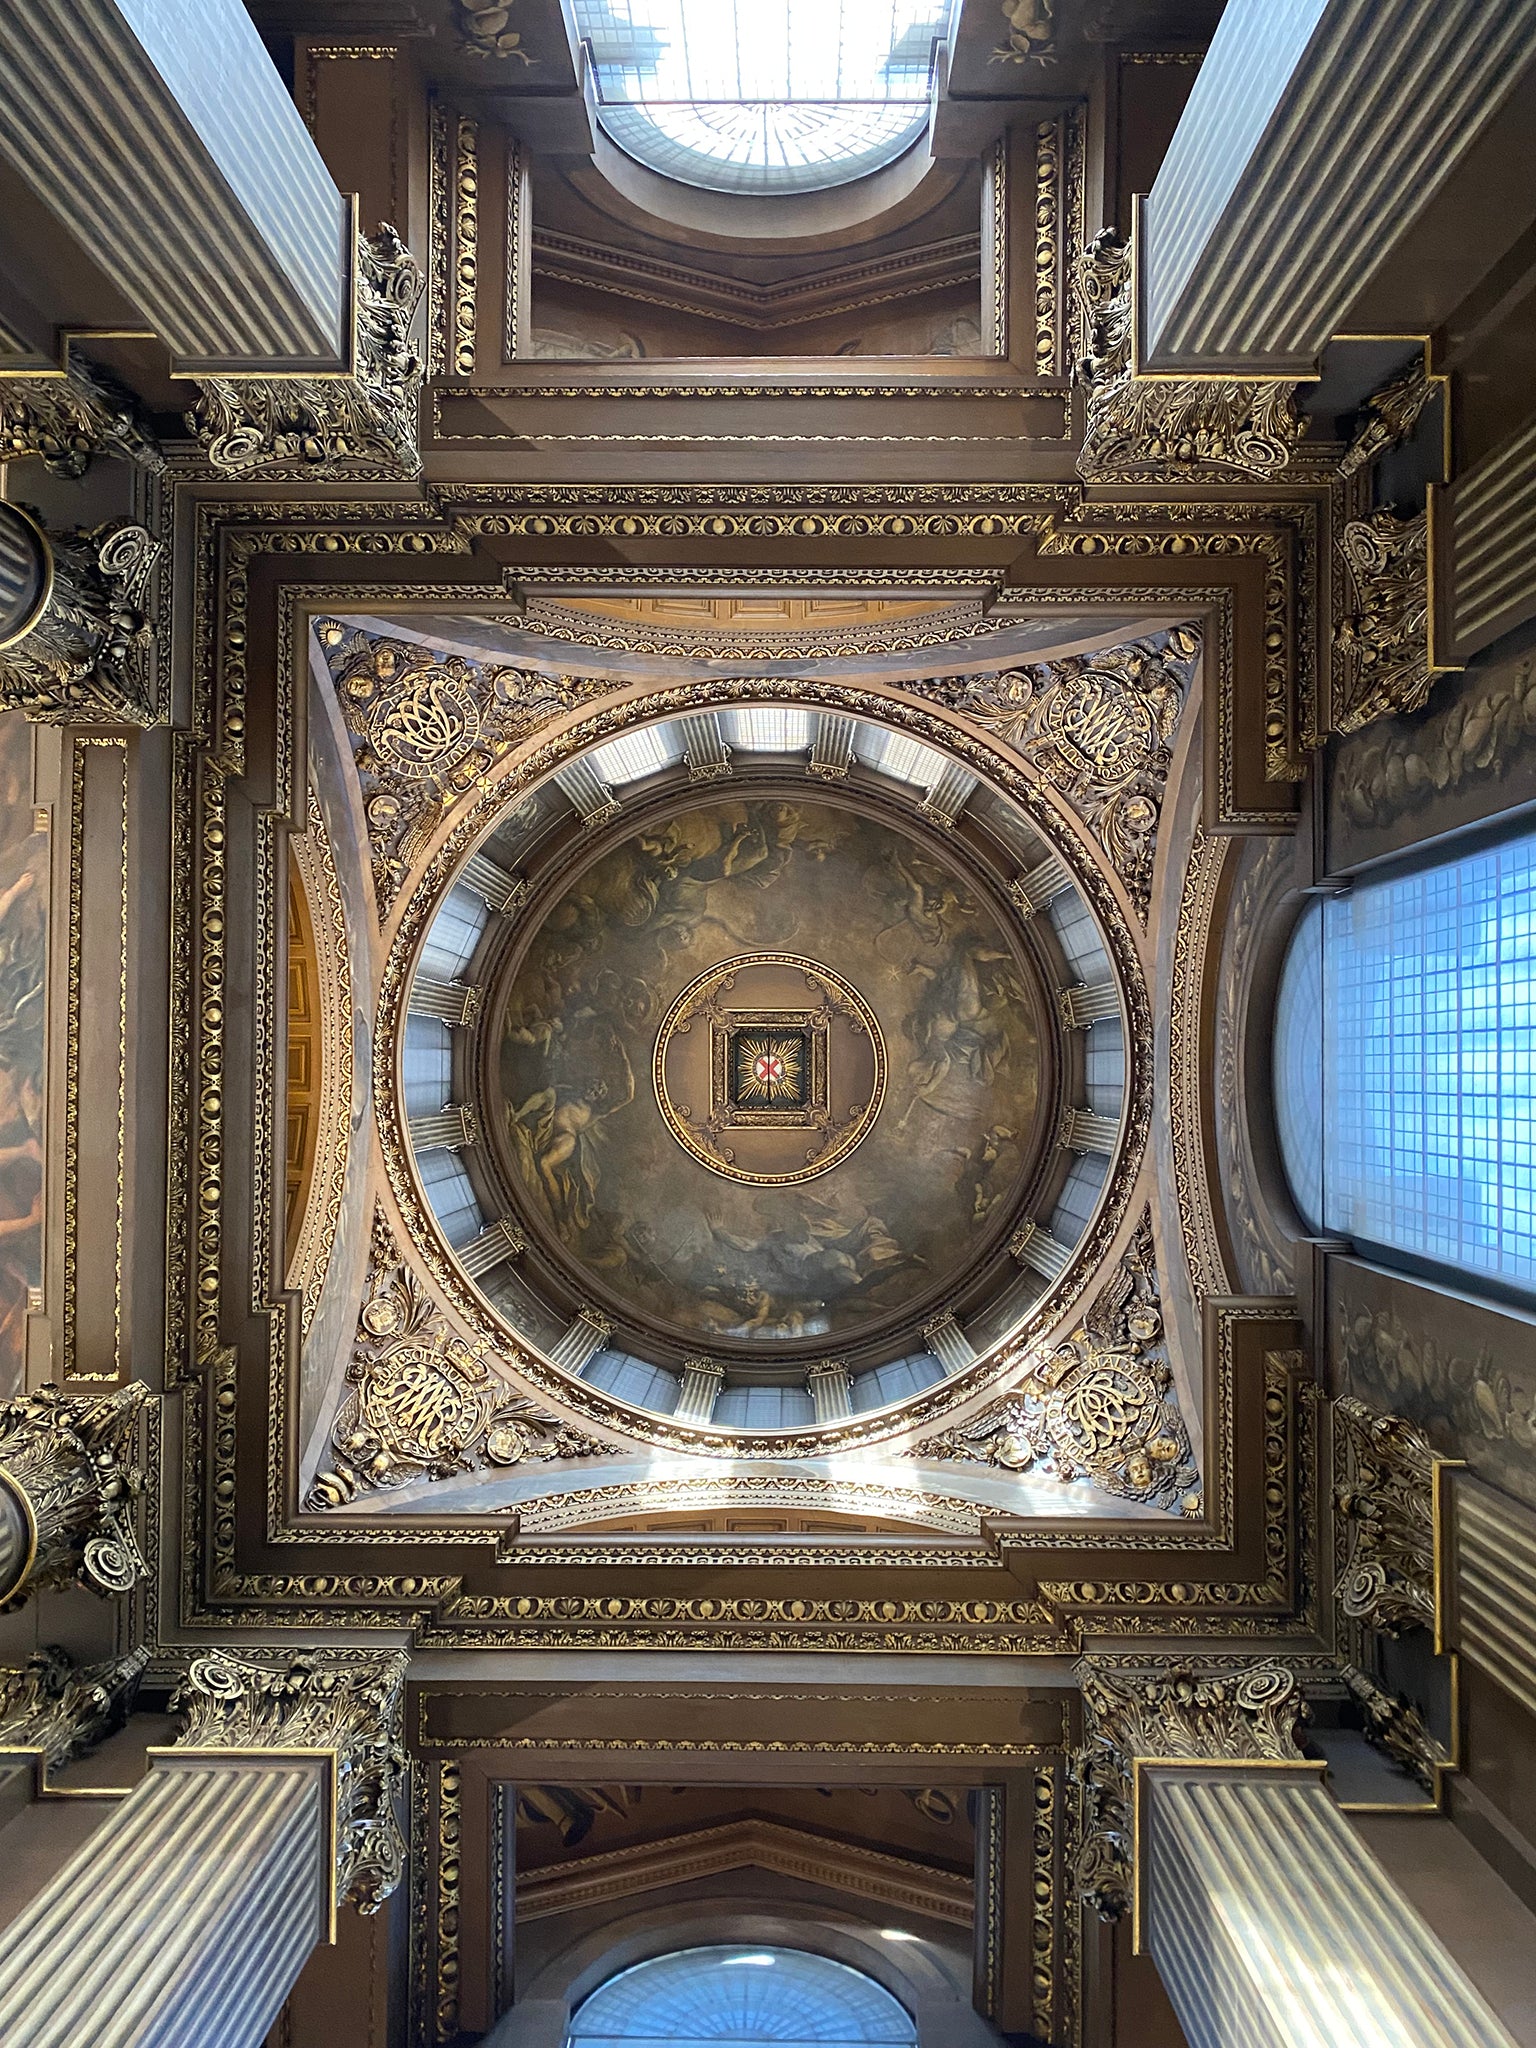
913, 1212, 1200, 1516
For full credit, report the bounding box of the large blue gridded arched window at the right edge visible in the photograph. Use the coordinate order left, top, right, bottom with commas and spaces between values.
1274, 834, 1536, 1298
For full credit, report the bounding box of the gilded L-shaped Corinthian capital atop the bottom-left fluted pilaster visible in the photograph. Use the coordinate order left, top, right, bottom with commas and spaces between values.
172, 1651, 408, 1913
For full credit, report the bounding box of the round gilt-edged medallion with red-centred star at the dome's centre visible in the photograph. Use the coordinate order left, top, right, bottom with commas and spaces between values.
651, 952, 887, 1188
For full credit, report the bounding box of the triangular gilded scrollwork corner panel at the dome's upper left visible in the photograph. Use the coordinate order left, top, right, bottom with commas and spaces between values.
315, 618, 604, 918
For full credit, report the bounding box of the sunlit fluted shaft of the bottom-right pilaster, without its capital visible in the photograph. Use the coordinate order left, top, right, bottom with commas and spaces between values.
1141, 1765, 1513, 2048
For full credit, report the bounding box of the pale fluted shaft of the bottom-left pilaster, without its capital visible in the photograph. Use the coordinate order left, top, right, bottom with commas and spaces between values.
0, 1755, 332, 2048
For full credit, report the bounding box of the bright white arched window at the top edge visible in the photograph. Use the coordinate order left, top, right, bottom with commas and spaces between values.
573, 0, 952, 193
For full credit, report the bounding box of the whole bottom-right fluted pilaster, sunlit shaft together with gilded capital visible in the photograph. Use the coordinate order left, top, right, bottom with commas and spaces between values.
1075, 1659, 1511, 2048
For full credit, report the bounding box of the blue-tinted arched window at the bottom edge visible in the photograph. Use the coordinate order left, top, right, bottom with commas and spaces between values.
567, 1948, 918, 2048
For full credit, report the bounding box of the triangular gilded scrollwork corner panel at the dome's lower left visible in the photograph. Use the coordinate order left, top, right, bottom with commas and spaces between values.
305, 1217, 602, 1509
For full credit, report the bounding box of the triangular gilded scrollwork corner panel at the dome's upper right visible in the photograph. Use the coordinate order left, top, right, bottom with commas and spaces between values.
928, 627, 1200, 918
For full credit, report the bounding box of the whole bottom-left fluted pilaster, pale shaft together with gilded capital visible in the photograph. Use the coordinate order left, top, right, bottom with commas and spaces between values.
0, 1653, 406, 2048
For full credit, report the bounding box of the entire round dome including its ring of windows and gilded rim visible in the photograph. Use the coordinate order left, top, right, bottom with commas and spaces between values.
391, 696, 1149, 1456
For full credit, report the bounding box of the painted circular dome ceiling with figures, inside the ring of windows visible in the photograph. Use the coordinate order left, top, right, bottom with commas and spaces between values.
481, 793, 1053, 1352
